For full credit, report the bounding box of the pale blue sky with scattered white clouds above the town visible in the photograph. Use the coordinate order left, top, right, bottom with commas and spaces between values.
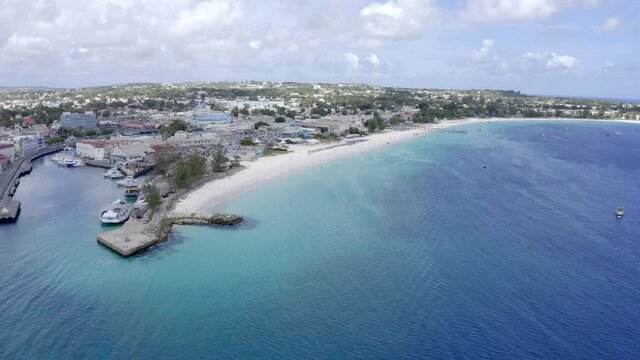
0, 0, 640, 99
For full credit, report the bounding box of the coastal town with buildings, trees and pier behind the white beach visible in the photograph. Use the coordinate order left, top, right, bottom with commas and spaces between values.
0, 82, 640, 256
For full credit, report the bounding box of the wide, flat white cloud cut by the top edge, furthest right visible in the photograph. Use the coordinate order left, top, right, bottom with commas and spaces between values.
460, 0, 598, 22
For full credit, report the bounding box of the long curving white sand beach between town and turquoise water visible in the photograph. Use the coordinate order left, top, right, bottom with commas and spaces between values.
173, 118, 640, 212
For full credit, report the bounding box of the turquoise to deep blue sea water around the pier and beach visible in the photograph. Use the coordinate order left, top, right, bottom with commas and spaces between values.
0, 122, 640, 359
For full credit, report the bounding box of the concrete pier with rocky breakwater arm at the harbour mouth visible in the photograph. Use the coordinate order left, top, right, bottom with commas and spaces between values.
97, 212, 244, 257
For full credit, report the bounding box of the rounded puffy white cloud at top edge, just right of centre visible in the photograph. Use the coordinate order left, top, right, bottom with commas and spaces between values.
360, 0, 437, 40
